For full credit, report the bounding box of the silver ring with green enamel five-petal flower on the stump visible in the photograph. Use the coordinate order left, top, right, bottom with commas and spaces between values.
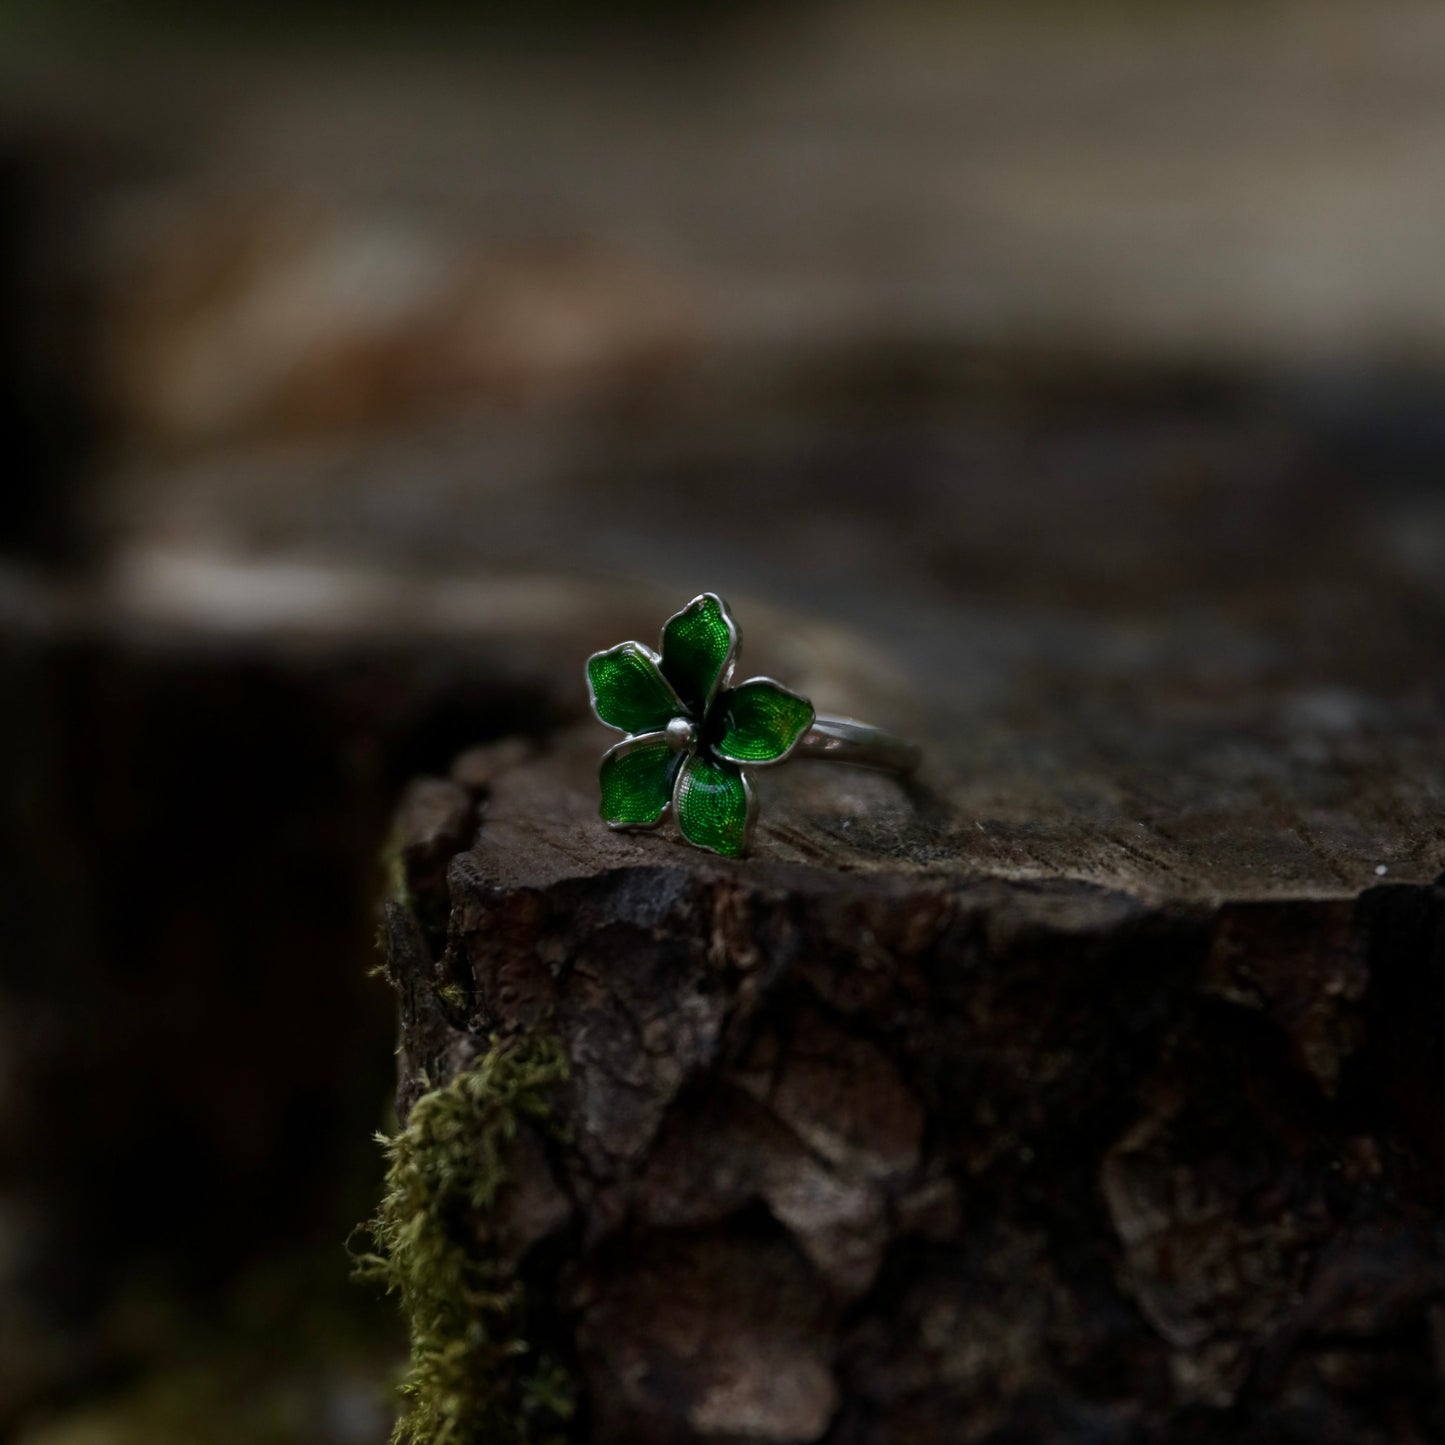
587, 592, 919, 858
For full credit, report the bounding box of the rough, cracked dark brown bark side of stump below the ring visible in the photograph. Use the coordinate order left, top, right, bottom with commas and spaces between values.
389, 716, 1445, 1445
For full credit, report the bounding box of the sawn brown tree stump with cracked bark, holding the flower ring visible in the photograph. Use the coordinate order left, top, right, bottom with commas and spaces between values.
367, 384, 1445, 1445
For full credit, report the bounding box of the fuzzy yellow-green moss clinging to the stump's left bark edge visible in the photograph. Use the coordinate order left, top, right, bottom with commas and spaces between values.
358, 1036, 575, 1445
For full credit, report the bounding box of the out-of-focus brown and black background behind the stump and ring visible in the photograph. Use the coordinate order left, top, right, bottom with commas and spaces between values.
0, 0, 1445, 1445
